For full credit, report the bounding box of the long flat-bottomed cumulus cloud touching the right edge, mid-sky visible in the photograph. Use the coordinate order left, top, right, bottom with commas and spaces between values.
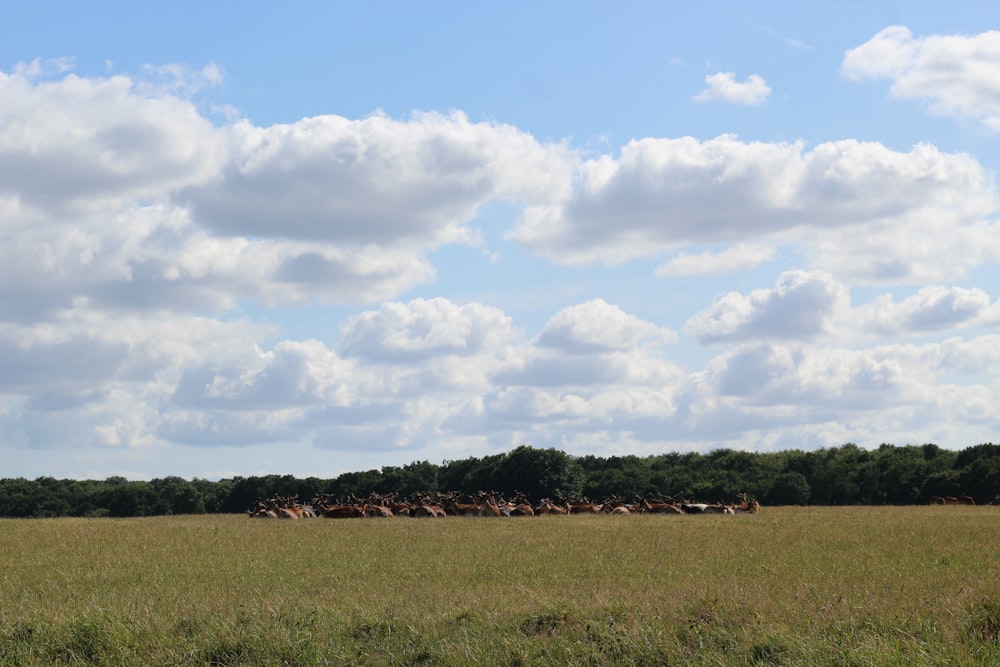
510, 135, 1000, 282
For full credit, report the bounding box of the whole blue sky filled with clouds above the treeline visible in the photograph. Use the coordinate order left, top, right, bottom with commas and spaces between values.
0, 0, 1000, 480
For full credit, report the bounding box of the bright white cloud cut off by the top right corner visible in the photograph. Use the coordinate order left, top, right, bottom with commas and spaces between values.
841, 26, 1000, 131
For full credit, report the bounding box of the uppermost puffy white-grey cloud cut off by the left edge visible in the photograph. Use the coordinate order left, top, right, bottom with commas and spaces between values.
0, 72, 223, 217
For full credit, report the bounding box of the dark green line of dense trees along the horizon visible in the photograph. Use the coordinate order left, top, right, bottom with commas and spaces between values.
0, 444, 1000, 517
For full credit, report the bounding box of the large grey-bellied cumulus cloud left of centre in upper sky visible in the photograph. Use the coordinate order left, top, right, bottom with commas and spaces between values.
181, 112, 572, 247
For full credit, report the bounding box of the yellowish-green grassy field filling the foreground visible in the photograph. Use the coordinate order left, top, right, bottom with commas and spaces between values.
0, 507, 1000, 666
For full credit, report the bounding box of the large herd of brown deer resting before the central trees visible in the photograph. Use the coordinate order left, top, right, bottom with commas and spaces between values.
247, 492, 760, 519
